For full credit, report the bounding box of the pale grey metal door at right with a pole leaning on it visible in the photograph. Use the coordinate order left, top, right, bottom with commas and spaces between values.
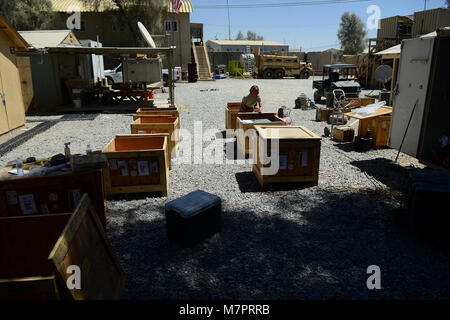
389, 38, 435, 157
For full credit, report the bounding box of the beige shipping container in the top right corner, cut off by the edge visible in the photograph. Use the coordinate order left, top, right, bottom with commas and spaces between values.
412, 8, 450, 38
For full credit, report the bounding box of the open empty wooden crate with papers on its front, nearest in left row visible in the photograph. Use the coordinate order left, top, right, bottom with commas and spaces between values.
103, 134, 170, 198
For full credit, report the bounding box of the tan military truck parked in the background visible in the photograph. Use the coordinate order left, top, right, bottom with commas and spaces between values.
255, 52, 313, 79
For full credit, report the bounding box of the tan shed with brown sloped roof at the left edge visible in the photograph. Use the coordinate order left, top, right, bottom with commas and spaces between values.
0, 13, 29, 134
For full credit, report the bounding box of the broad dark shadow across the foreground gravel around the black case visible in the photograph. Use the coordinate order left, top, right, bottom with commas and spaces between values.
108, 189, 450, 300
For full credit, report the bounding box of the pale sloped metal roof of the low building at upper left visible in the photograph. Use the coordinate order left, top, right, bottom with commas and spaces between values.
19, 30, 81, 49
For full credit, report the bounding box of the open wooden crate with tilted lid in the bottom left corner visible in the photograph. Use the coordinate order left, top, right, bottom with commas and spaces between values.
0, 194, 124, 300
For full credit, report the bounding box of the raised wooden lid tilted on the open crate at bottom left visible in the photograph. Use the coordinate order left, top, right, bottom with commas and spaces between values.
49, 195, 123, 300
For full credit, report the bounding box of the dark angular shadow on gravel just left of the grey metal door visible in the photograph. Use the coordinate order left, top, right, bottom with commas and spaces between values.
350, 158, 406, 191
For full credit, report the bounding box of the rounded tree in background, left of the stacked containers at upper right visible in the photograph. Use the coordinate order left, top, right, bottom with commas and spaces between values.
337, 12, 367, 55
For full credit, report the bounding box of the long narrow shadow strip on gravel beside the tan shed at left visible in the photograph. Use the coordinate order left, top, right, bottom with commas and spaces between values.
0, 114, 98, 156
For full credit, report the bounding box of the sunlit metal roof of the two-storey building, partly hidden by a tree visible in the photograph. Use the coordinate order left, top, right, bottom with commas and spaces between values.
50, 0, 194, 13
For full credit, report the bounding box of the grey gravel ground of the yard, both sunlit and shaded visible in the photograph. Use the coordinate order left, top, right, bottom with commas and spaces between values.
0, 79, 450, 299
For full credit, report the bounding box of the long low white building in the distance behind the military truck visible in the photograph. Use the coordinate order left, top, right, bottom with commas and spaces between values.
206, 40, 289, 53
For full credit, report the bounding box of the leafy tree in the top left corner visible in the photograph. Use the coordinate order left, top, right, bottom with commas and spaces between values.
1, 0, 53, 30
